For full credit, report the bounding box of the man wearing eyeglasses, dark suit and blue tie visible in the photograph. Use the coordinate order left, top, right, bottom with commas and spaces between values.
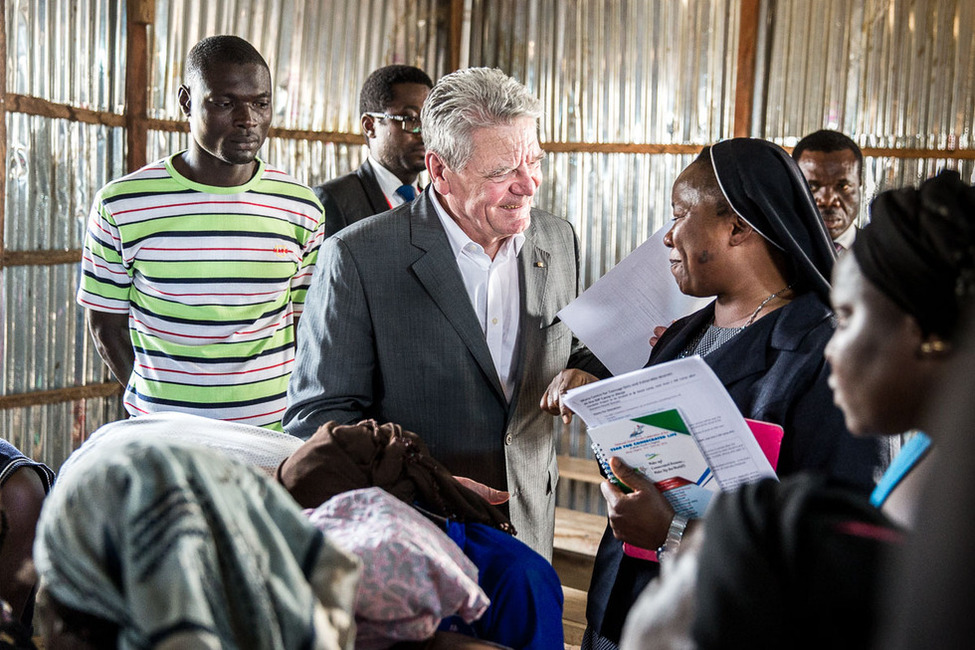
313, 65, 433, 237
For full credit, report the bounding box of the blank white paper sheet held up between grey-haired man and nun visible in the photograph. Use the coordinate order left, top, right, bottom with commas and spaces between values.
559, 224, 711, 375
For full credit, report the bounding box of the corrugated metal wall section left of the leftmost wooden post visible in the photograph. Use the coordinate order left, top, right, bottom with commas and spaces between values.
0, 0, 125, 466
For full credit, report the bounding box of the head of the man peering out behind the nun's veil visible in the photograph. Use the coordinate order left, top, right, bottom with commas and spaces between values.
792, 129, 863, 252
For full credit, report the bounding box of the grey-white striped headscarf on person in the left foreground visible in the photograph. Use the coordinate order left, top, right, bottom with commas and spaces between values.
34, 427, 358, 649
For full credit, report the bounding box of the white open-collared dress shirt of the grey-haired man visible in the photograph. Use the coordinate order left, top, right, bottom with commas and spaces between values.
430, 191, 525, 401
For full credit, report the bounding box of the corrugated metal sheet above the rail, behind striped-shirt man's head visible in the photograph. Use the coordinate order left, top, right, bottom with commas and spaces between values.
149, 0, 447, 133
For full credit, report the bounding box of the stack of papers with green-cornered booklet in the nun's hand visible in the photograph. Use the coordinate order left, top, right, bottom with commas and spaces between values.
562, 356, 775, 517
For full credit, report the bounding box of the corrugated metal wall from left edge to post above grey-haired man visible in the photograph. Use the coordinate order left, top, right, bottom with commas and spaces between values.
0, 0, 446, 468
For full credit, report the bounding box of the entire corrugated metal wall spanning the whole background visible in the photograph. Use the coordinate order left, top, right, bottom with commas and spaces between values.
0, 0, 975, 486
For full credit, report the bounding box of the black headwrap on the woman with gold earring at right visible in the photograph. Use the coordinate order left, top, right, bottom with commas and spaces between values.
852, 171, 975, 339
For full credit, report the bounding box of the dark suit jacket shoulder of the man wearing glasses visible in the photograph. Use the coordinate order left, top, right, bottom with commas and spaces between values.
312, 158, 389, 237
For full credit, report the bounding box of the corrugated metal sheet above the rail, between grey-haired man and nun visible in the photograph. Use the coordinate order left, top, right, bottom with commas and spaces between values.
467, 0, 740, 144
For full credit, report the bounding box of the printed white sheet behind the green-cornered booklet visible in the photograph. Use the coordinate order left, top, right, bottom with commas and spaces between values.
562, 356, 775, 490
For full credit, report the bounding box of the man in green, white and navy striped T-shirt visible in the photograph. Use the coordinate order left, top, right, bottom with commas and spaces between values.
78, 36, 324, 429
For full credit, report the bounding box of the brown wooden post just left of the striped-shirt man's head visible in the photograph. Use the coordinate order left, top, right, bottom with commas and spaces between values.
125, 0, 156, 172
